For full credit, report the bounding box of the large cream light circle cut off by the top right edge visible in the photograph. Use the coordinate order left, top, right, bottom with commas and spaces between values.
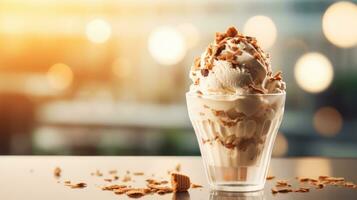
322, 1, 357, 48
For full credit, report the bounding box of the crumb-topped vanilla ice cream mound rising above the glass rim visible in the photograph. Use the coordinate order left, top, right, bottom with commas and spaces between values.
190, 27, 285, 95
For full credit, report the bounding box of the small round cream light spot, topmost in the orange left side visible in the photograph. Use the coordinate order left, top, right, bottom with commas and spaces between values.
86, 19, 112, 43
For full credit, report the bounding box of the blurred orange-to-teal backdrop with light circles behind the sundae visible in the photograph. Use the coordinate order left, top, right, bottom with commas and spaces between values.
0, 0, 357, 157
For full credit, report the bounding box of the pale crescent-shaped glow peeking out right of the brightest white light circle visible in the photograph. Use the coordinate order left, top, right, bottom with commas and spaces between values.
177, 23, 200, 49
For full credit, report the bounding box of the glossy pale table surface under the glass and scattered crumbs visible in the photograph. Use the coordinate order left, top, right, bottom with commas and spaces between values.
0, 156, 357, 200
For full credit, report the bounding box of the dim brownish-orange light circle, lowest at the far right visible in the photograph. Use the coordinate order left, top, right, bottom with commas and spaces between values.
313, 107, 343, 137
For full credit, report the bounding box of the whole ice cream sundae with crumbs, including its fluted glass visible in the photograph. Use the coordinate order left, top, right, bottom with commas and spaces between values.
186, 27, 286, 192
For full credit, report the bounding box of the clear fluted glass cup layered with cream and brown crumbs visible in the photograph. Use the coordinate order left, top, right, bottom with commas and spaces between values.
186, 93, 285, 192
